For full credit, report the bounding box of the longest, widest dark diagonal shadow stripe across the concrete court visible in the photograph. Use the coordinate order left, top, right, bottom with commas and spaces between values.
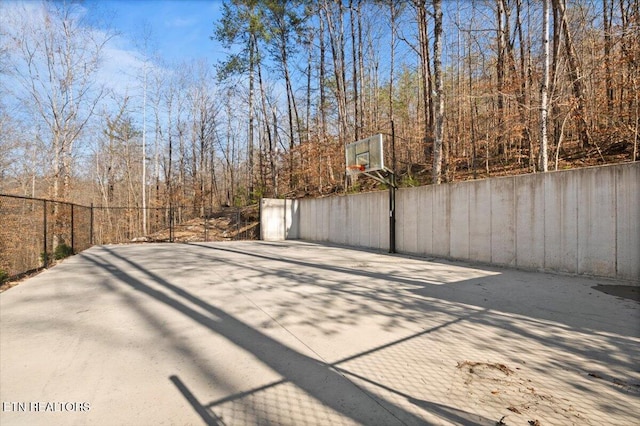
84, 246, 491, 425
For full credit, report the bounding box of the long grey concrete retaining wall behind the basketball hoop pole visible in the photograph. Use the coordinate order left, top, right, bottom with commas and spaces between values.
263, 162, 640, 281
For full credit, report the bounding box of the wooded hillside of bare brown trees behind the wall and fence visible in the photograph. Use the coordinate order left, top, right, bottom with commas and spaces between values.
0, 0, 640, 215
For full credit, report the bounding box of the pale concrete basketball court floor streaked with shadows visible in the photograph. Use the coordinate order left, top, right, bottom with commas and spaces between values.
0, 241, 640, 426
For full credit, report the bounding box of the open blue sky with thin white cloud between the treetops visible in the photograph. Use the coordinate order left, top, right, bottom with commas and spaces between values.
0, 0, 236, 153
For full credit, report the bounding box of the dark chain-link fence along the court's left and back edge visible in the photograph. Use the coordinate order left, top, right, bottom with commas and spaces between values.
0, 194, 260, 284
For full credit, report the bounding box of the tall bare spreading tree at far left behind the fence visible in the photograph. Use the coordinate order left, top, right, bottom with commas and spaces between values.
7, 3, 111, 200
